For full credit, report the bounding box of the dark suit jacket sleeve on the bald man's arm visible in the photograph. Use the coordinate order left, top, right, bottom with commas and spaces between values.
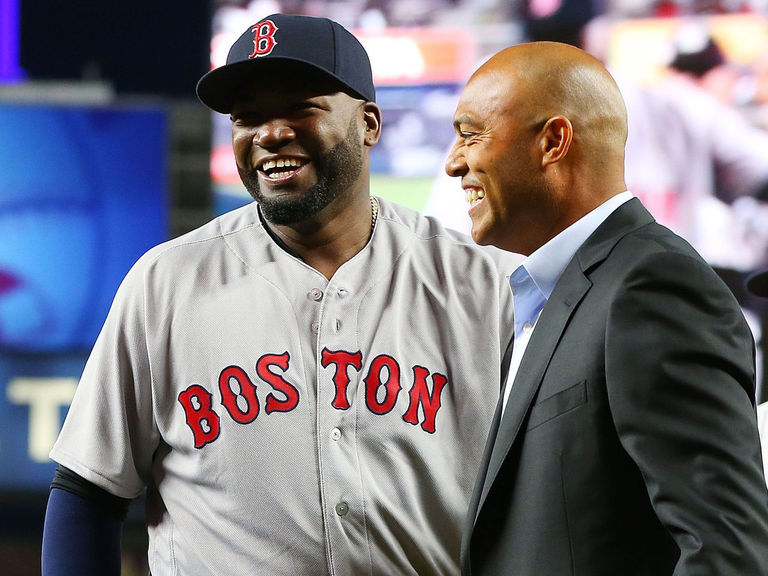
606, 253, 768, 576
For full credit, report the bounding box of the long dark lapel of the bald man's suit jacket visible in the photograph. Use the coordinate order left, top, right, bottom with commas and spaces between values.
472, 198, 653, 519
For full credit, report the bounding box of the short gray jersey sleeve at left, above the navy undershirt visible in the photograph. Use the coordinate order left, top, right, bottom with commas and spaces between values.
50, 257, 159, 498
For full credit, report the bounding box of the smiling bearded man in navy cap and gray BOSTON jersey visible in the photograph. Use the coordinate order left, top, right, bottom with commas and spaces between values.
43, 14, 519, 576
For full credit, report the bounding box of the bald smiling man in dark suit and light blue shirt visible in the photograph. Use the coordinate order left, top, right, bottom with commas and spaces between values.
446, 42, 768, 576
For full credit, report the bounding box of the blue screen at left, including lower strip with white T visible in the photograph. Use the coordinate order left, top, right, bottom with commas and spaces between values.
0, 104, 169, 492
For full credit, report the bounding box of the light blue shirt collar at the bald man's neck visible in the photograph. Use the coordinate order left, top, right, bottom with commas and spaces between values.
520, 190, 632, 299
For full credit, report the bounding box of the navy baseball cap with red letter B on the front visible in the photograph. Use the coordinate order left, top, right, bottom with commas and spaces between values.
197, 14, 376, 114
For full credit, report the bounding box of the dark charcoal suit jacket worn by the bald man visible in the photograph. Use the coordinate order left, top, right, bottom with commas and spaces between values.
462, 199, 768, 576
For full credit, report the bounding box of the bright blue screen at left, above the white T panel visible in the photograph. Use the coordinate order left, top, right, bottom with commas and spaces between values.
0, 105, 168, 351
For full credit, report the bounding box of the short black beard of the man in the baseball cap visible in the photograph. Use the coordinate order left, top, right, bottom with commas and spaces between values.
241, 118, 363, 225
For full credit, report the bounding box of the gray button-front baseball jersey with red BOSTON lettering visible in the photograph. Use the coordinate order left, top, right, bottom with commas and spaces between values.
51, 201, 517, 576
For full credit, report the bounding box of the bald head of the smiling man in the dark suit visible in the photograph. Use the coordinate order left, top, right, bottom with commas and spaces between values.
446, 42, 627, 254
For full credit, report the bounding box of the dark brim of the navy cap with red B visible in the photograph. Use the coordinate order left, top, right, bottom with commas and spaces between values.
196, 56, 367, 114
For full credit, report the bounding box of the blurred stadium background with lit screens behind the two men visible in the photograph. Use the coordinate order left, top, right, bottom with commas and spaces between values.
0, 0, 768, 576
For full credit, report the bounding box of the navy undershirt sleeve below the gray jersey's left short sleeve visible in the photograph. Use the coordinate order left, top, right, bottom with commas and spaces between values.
42, 469, 129, 576
